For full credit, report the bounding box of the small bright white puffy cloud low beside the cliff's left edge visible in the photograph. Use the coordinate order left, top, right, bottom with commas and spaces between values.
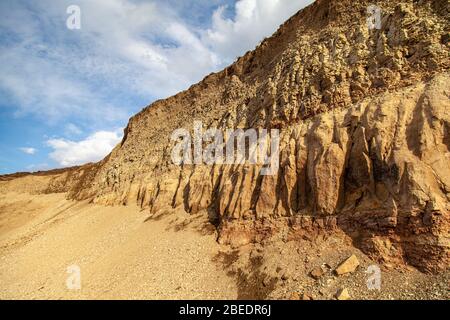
47, 130, 122, 167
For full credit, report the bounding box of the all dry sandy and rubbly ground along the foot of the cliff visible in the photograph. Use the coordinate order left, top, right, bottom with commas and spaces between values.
0, 192, 450, 299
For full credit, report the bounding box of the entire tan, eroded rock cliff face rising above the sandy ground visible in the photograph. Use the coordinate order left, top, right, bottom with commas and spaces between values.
19, 0, 450, 271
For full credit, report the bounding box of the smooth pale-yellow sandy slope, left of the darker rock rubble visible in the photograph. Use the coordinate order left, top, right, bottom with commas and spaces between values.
0, 193, 237, 299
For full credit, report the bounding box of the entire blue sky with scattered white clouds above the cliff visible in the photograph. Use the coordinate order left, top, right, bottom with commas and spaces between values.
0, 0, 312, 174
